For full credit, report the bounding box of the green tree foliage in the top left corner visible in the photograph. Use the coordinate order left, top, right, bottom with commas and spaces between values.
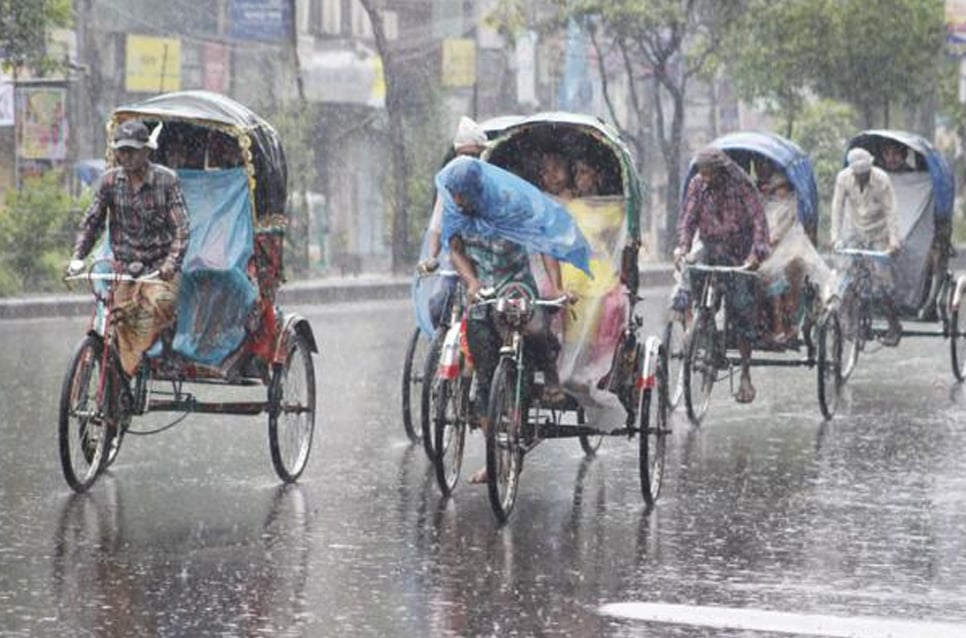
0, 0, 71, 70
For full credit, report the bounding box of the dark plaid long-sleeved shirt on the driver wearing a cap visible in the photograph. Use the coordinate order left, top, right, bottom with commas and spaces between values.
74, 163, 189, 272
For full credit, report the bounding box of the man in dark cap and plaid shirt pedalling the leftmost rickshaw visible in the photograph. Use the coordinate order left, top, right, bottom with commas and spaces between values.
67, 120, 189, 376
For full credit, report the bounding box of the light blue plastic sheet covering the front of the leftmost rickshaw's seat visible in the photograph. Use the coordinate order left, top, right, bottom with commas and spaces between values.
172, 168, 258, 366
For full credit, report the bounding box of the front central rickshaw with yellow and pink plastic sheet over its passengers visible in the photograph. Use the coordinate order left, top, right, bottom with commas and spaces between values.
433, 112, 670, 523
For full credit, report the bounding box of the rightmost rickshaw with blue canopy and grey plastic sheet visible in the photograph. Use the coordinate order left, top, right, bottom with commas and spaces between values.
837, 129, 966, 381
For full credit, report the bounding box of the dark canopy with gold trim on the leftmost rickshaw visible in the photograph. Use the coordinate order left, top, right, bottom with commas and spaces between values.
109, 91, 287, 224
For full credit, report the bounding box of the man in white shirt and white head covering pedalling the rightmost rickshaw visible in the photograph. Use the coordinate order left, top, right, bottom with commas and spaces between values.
831, 147, 902, 346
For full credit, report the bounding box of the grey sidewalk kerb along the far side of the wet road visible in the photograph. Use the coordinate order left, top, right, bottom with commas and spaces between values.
0, 262, 671, 320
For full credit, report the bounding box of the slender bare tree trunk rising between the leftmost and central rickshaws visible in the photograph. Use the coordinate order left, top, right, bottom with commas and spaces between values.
359, 0, 409, 272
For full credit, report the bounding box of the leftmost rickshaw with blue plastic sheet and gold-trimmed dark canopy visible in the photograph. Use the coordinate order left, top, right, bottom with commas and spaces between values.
59, 91, 318, 492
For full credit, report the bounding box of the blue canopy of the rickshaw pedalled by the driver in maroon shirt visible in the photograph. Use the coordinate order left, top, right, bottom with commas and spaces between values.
681, 131, 818, 237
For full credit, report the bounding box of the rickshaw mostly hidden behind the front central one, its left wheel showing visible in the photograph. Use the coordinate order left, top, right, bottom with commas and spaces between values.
402, 115, 521, 460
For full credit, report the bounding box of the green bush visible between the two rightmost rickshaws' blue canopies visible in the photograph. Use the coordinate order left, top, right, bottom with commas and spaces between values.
792, 100, 857, 242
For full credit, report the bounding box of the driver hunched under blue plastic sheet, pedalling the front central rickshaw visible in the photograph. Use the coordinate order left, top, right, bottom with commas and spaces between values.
436, 158, 590, 483
